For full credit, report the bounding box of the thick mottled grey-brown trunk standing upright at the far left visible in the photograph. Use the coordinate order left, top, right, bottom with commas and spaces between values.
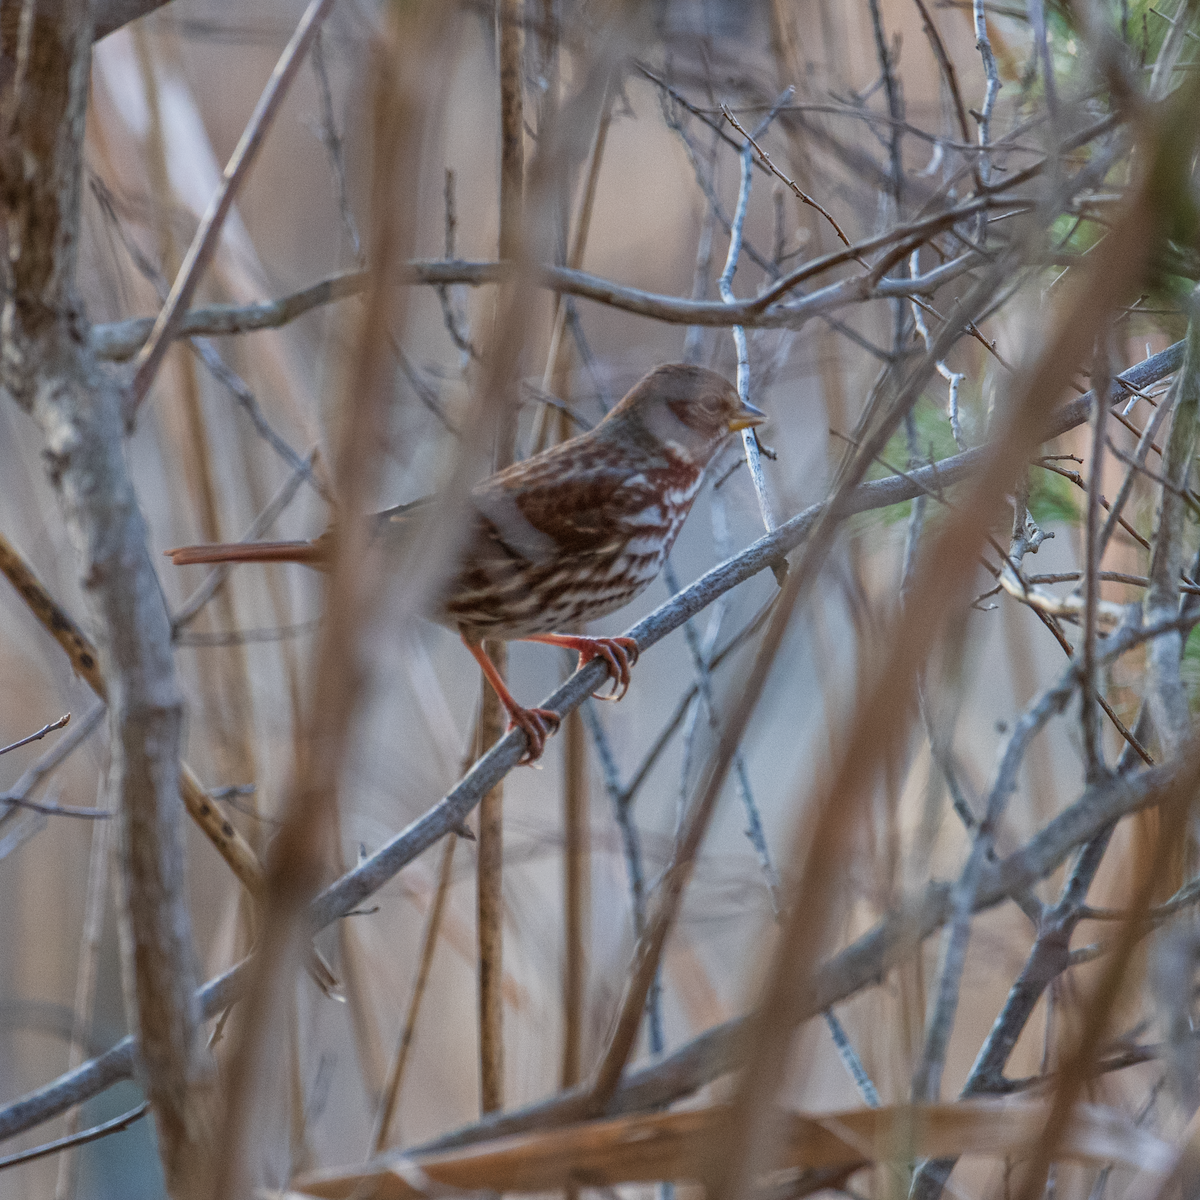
0, 0, 205, 1196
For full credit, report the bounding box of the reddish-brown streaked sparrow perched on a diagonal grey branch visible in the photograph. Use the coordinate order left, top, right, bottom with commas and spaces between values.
167, 362, 767, 763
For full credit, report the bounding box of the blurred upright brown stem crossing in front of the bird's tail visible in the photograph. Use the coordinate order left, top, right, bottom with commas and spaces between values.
204, 10, 444, 1196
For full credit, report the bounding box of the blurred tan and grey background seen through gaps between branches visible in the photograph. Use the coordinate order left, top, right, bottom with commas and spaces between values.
0, 0, 1194, 1200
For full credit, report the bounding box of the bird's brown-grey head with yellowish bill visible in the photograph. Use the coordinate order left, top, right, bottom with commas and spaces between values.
606, 362, 767, 467
